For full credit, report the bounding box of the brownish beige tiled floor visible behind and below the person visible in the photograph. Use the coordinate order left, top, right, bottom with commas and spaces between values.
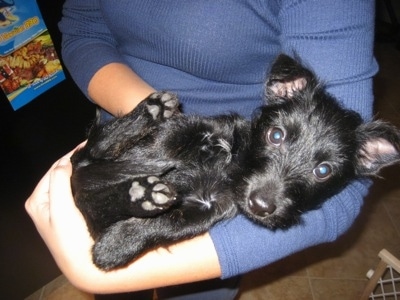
27, 44, 400, 300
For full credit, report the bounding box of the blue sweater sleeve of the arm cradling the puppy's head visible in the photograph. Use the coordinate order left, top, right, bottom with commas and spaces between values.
210, 0, 377, 278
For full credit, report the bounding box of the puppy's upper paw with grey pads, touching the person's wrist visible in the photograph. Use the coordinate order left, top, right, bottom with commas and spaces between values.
147, 92, 179, 120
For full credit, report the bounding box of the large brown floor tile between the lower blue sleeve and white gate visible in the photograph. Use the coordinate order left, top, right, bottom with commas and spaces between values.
307, 196, 400, 279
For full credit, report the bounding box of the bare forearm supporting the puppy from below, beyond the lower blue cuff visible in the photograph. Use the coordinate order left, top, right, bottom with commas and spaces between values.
61, 234, 221, 294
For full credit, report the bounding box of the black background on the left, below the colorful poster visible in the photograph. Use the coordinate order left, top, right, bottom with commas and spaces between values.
0, 0, 95, 300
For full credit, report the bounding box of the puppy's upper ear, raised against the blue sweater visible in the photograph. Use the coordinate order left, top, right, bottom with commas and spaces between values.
265, 54, 315, 102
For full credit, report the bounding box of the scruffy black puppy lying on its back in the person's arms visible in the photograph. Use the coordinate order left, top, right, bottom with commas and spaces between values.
72, 55, 400, 270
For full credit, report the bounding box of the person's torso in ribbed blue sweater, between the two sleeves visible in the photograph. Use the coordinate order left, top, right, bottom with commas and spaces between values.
99, 0, 280, 116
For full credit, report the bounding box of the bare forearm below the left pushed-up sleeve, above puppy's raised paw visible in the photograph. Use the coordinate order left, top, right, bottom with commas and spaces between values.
88, 63, 155, 116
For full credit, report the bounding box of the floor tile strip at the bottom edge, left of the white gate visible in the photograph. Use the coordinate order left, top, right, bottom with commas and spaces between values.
311, 279, 367, 300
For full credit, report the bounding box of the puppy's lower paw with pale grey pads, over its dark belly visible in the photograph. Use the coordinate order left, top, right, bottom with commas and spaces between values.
129, 176, 176, 217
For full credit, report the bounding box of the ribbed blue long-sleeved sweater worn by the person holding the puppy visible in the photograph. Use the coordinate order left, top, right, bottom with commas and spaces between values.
60, 0, 377, 278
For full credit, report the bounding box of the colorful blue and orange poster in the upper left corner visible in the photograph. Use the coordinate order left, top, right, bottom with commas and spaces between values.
0, 0, 65, 110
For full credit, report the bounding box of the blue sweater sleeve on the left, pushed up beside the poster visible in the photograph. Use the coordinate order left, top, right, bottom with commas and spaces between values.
59, 0, 123, 98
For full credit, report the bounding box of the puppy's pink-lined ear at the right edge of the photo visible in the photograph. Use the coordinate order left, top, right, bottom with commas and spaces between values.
356, 121, 400, 176
